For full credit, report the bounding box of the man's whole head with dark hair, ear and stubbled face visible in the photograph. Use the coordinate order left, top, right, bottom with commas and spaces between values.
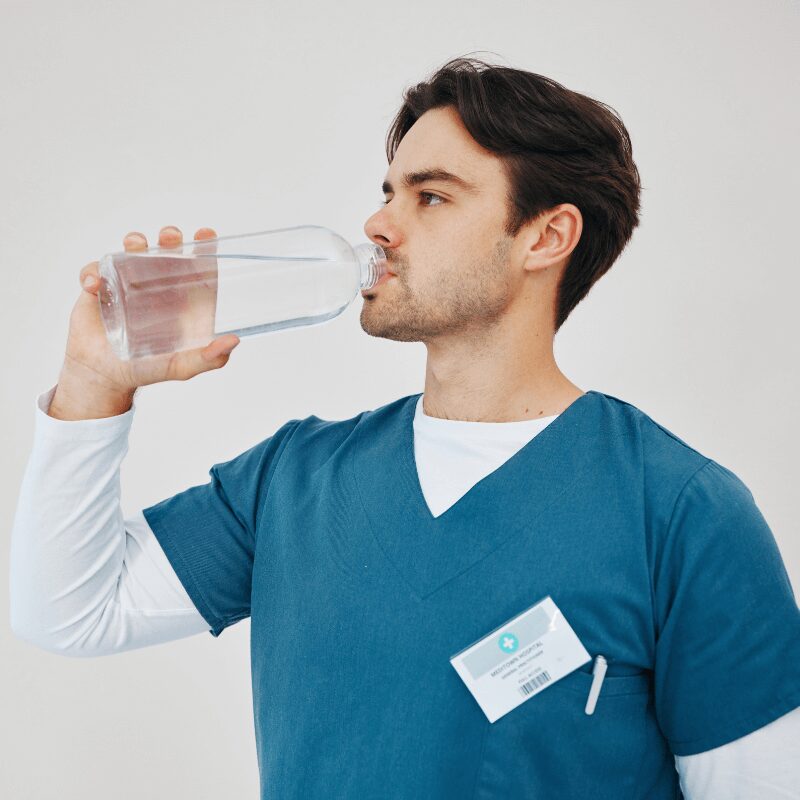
361, 59, 640, 342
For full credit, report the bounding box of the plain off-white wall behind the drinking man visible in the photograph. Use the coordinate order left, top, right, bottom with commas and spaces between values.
0, 0, 800, 800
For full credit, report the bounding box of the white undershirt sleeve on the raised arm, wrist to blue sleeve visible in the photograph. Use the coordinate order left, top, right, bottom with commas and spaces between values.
10, 387, 209, 656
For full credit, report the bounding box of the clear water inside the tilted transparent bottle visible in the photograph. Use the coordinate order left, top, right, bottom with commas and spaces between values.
105, 250, 359, 358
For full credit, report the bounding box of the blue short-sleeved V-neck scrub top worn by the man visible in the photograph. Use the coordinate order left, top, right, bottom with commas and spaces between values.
144, 390, 800, 800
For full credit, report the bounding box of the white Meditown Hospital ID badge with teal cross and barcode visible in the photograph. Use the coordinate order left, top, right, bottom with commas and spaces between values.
450, 595, 591, 722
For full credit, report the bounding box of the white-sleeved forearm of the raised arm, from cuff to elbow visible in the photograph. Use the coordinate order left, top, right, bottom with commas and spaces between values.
10, 389, 133, 649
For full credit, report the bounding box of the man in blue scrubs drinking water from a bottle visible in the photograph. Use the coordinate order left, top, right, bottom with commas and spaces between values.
12, 59, 800, 800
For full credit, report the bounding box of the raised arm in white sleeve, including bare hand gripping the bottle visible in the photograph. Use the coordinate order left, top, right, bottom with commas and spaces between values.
10, 226, 239, 655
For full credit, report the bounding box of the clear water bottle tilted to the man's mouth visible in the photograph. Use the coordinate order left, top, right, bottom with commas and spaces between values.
98, 225, 388, 361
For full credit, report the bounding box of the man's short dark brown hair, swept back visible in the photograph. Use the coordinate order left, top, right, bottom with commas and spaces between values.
386, 57, 641, 331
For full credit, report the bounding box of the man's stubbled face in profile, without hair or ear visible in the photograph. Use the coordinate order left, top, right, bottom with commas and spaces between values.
361, 107, 522, 342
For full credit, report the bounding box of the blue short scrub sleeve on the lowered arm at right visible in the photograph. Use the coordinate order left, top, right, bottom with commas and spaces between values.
654, 461, 800, 756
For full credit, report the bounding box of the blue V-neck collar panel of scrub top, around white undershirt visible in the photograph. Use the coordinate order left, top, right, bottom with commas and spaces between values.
352, 389, 603, 597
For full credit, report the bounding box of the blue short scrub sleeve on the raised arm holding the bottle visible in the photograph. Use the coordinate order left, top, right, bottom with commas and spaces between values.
142, 420, 299, 637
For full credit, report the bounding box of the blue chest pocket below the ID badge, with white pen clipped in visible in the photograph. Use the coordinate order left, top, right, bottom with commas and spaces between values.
473, 662, 664, 800
